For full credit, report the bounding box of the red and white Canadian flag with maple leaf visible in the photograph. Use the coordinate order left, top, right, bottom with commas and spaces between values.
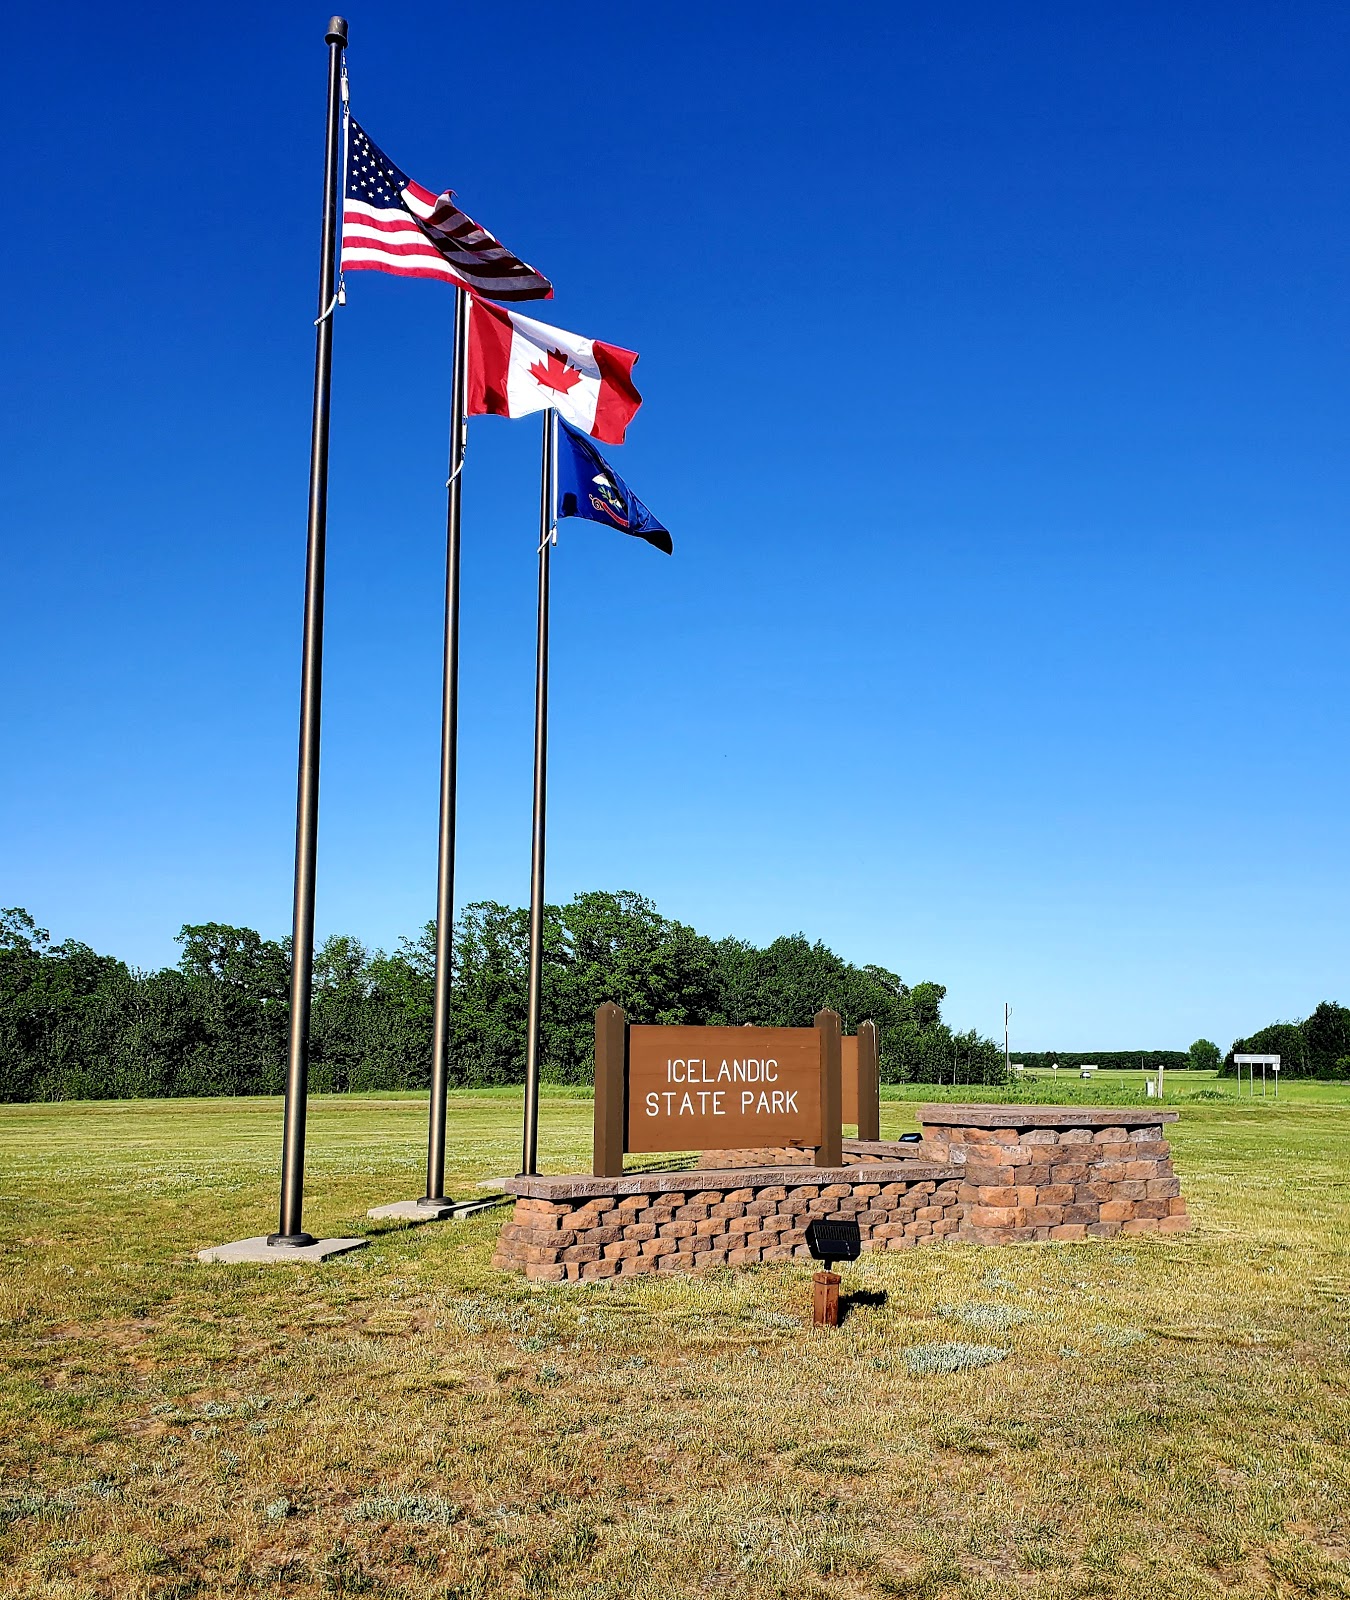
469, 294, 641, 445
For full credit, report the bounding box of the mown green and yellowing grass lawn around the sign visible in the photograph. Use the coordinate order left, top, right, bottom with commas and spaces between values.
0, 1074, 1350, 1600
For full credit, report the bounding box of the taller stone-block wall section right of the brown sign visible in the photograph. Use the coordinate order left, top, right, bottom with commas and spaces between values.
918, 1106, 1190, 1245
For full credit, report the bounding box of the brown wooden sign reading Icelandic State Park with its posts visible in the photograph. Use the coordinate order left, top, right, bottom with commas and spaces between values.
595, 1005, 843, 1178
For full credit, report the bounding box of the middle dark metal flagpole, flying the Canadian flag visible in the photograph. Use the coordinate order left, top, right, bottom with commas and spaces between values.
417, 288, 469, 1208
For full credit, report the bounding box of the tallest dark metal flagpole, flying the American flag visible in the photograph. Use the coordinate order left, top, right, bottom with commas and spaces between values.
267, 16, 347, 1245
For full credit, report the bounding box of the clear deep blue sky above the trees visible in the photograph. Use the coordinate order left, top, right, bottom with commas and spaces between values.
0, 0, 1350, 1054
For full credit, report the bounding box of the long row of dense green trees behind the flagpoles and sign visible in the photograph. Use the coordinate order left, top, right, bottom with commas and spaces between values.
0, 891, 1005, 1101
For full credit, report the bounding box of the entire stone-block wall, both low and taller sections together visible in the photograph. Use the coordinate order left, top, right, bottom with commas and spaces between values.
493, 1106, 1190, 1283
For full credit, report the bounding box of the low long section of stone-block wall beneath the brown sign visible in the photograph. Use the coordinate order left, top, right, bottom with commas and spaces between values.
493, 1162, 963, 1283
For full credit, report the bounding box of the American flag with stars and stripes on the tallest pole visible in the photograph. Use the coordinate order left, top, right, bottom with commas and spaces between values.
342, 117, 553, 301
